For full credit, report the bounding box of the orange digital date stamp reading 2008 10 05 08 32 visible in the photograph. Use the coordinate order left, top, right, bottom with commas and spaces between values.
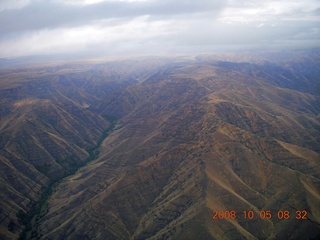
212, 210, 308, 220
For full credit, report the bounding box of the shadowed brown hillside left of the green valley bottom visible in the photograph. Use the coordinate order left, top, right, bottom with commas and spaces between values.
0, 59, 170, 239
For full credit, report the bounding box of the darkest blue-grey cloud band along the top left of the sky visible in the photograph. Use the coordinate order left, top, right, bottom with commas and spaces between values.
0, 0, 223, 34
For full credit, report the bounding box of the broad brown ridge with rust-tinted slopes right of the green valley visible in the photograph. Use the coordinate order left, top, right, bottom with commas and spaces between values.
23, 55, 320, 239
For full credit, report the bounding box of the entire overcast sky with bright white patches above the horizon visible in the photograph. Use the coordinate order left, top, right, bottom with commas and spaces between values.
0, 0, 320, 58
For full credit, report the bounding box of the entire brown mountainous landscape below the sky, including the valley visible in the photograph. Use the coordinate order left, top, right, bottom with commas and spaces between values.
0, 51, 320, 239
